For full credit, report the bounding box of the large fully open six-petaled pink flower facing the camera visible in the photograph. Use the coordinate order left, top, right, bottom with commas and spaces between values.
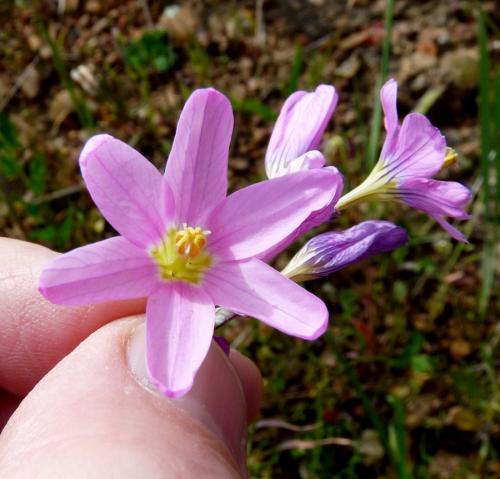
40, 89, 341, 397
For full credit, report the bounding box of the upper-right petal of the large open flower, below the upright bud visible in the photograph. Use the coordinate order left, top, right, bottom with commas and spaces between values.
207, 169, 342, 259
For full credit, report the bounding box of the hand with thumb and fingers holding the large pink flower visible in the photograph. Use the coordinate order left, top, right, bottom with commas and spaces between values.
0, 238, 262, 479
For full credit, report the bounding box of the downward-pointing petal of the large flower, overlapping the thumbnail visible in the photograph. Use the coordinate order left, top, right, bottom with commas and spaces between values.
146, 283, 215, 397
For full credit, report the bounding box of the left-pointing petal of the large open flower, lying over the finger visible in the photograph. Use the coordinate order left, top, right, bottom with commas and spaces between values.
39, 236, 158, 304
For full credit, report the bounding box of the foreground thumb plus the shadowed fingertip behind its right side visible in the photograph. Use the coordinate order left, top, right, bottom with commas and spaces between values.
0, 318, 261, 479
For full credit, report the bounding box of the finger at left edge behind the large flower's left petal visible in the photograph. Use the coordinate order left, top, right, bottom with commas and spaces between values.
0, 238, 145, 396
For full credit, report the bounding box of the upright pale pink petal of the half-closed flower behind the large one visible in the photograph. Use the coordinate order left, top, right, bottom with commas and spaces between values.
266, 85, 338, 178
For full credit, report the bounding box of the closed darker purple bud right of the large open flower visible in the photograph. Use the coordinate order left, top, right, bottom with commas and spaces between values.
282, 221, 408, 281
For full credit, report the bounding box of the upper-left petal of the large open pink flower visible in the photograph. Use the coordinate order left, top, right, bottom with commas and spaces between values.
80, 135, 169, 246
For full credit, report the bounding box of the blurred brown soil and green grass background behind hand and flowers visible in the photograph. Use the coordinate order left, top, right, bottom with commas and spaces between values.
0, 0, 500, 479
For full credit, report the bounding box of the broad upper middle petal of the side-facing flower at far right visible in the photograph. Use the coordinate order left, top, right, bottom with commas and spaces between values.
381, 113, 446, 179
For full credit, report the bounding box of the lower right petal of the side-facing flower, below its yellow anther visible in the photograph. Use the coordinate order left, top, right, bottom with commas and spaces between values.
398, 178, 472, 220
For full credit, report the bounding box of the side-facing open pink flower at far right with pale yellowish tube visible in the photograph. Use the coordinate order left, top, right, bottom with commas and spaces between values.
337, 80, 471, 241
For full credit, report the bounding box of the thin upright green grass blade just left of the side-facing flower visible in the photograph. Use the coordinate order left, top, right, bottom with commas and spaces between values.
366, 0, 395, 170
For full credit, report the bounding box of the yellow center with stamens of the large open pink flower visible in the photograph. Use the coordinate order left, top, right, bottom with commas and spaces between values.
150, 224, 212, 284
